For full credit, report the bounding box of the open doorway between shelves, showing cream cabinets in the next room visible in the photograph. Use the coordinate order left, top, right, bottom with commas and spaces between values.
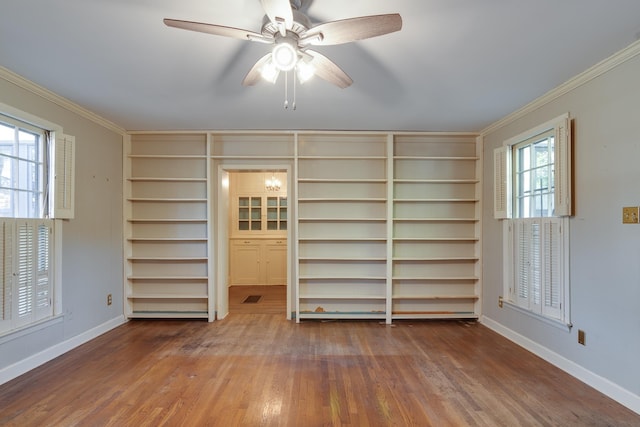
217, 166, 291, 318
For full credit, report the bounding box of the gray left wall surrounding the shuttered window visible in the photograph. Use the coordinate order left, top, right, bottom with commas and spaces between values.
0, 76, 123, 370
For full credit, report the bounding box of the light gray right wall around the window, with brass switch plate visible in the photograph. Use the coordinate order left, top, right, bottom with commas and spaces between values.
482, 56, 640, 396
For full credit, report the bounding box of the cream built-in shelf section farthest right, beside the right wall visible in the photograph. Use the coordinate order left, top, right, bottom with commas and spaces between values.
391, 134, 480, 319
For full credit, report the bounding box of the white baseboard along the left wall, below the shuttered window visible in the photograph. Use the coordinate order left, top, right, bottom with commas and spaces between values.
0, 316, 126, 385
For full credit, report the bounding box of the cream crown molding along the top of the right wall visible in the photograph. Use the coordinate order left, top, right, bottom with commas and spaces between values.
480, 40, 640, 136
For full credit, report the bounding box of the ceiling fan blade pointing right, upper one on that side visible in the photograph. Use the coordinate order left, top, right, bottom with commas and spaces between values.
300, 13, 402, 46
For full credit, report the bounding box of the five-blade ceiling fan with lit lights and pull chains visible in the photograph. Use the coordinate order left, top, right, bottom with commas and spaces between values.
164, 0, 402, 88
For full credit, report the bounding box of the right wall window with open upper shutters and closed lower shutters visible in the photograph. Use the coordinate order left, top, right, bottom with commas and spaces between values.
494, 115, 571, 324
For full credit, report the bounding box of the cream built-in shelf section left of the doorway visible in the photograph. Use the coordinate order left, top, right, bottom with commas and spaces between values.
125, 134, 209, 319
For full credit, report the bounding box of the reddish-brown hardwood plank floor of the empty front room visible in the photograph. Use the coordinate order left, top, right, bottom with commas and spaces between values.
0, 290, 640, 427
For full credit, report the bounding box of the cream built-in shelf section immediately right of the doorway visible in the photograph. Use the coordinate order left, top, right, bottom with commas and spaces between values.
296, 134, 388, 320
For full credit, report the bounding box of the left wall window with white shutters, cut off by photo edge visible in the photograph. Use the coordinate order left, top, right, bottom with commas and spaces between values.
0, 104, 75, 334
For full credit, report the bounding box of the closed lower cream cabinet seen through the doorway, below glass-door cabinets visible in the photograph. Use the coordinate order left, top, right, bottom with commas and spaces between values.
229, 239, 287, 285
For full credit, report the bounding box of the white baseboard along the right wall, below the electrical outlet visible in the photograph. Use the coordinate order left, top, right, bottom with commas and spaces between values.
480, 316, 640, 414
